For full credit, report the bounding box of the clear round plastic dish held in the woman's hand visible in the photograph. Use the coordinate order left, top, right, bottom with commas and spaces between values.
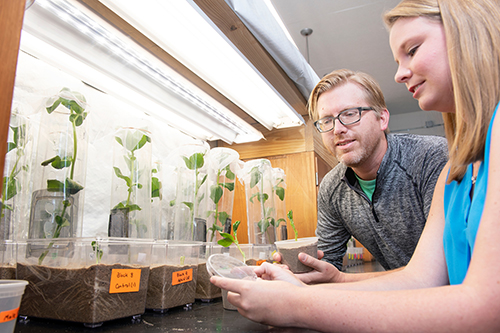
207, 254, 257, 280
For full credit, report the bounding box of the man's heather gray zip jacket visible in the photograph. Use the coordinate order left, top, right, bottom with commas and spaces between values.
316, 134, 448, 269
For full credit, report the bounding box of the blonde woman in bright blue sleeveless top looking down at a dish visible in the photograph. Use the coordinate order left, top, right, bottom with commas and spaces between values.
212, 0, 500, 332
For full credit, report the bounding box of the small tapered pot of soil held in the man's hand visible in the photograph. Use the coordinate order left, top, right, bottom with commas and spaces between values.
275, 237, 318, 273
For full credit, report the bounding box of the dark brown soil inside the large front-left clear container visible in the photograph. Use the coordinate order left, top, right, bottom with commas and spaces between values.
17, 263, 149, 326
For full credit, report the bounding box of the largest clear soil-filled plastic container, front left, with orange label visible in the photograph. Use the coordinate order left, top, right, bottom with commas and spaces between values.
17, 238, 153, 327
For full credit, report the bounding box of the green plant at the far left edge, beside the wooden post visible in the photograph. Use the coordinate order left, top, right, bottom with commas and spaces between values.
0, 116, 29, 218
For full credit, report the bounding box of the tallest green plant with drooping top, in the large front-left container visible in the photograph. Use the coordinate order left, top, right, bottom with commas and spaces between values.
38, 88, 88, 265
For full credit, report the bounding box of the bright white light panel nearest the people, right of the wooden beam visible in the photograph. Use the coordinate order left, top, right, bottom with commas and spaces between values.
97, 0, 304, 129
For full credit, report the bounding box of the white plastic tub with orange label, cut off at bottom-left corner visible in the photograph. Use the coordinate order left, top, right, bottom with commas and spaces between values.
0, 280, 28, 333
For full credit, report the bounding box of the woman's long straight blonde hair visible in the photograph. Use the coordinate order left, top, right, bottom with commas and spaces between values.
384, 0, 500, 182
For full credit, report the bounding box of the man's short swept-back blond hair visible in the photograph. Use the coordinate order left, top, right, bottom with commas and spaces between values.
307, 69, 387, 128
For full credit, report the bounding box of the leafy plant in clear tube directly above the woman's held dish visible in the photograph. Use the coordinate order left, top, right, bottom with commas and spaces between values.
208, 164, 236, 242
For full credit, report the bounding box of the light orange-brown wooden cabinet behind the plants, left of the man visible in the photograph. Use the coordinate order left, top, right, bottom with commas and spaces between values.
219, 116, 337, 243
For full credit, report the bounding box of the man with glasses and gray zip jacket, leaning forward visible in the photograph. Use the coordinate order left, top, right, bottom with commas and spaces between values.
292, 69, 448, 283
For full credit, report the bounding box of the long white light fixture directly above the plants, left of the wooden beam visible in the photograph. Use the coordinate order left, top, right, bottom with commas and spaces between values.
21, 0, 262, 143
